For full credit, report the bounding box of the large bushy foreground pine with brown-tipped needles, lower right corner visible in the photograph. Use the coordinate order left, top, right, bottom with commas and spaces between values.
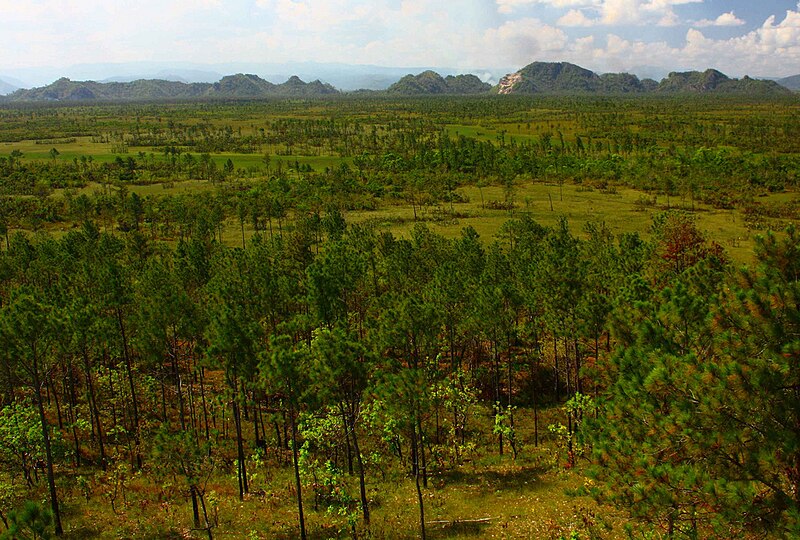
589, 224, 800, 538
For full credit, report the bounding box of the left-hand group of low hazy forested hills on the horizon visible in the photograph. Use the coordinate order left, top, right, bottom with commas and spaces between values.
4, 73, 338, 101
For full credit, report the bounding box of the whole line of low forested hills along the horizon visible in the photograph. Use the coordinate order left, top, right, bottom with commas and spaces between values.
0, 62, 800, 102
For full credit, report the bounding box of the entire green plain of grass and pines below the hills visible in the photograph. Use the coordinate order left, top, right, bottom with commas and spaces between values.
0, 96, 800, 539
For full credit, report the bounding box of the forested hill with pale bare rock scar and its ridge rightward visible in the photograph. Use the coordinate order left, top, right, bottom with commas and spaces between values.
495, 62, 791, 96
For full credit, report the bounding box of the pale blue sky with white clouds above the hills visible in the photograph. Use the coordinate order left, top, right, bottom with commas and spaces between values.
0, 0, 800, 77
